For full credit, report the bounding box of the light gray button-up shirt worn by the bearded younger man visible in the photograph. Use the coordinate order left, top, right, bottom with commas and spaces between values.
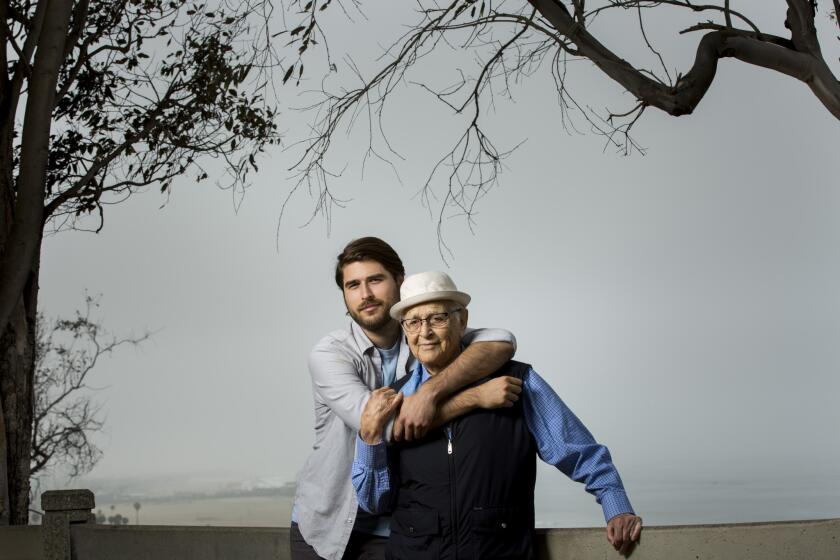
294, 321, 516, 560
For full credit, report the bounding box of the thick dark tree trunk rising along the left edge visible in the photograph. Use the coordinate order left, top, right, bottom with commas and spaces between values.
0, 0, 73, 525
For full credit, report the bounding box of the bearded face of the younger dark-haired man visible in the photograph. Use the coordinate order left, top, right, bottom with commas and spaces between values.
341, 260, 402, 332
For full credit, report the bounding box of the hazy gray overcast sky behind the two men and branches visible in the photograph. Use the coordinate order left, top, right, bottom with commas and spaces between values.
40, 2, 840, 523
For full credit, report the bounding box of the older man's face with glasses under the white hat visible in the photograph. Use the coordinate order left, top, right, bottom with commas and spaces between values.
403, 301, 467, 374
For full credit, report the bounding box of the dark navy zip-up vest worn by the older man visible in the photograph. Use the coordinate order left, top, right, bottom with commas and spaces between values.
386, 361, 537, 560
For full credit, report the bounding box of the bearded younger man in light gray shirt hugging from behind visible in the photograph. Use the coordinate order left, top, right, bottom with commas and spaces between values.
290, 237, 519, 560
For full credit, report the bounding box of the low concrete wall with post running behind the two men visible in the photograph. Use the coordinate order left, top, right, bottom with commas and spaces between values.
0, 490, 840, 560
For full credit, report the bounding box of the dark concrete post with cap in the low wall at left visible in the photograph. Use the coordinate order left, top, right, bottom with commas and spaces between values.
41, 490, 96, 560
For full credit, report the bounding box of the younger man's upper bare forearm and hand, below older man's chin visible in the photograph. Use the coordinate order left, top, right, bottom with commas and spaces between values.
421, 342, 514, 403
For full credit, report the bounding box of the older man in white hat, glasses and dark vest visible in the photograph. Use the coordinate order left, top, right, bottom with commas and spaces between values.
353, 272, 642, 560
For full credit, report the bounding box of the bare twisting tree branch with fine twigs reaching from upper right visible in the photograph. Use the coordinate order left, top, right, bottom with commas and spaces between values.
284, 0, 840, 255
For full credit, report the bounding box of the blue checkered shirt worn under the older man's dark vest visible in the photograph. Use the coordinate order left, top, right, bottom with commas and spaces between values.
353, 364, 633, 521
